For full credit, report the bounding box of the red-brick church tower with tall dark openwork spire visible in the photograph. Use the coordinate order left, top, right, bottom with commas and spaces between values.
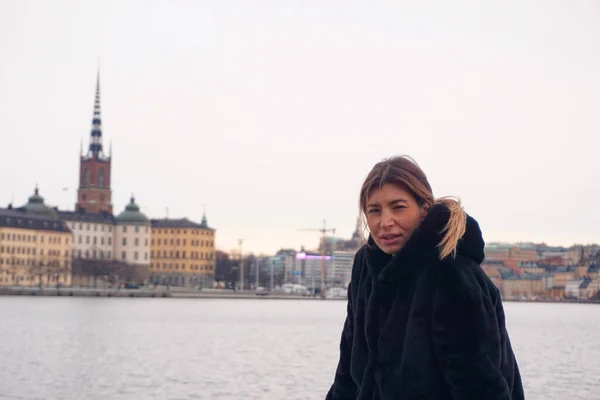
75, 72, 113, 214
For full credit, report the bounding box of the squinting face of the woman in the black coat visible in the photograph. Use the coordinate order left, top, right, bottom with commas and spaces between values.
365, 183, 428, 254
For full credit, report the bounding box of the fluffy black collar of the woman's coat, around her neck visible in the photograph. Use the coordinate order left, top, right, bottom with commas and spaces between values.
367, 204, 485, 282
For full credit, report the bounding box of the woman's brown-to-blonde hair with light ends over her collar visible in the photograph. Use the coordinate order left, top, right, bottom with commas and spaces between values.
359, 156, 467, 259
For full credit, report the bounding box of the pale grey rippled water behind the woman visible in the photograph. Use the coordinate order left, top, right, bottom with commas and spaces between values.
0, 297, 600, 400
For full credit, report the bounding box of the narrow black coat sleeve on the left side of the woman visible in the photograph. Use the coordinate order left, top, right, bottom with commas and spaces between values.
325, 268, 357, 400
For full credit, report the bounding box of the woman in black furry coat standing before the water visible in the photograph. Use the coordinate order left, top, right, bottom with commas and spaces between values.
327, 157, 525, 400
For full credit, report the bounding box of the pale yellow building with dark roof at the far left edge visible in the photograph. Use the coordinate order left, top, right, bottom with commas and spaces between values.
0, 188, 73, 286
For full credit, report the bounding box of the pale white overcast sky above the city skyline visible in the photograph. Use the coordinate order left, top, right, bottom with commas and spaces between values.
0, 0, 600, 253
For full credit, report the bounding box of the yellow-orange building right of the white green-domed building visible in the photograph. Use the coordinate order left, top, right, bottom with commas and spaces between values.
150, 216, 215, 287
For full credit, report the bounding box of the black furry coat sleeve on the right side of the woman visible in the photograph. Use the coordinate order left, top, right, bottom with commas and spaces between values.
432, 267, 511, 400
